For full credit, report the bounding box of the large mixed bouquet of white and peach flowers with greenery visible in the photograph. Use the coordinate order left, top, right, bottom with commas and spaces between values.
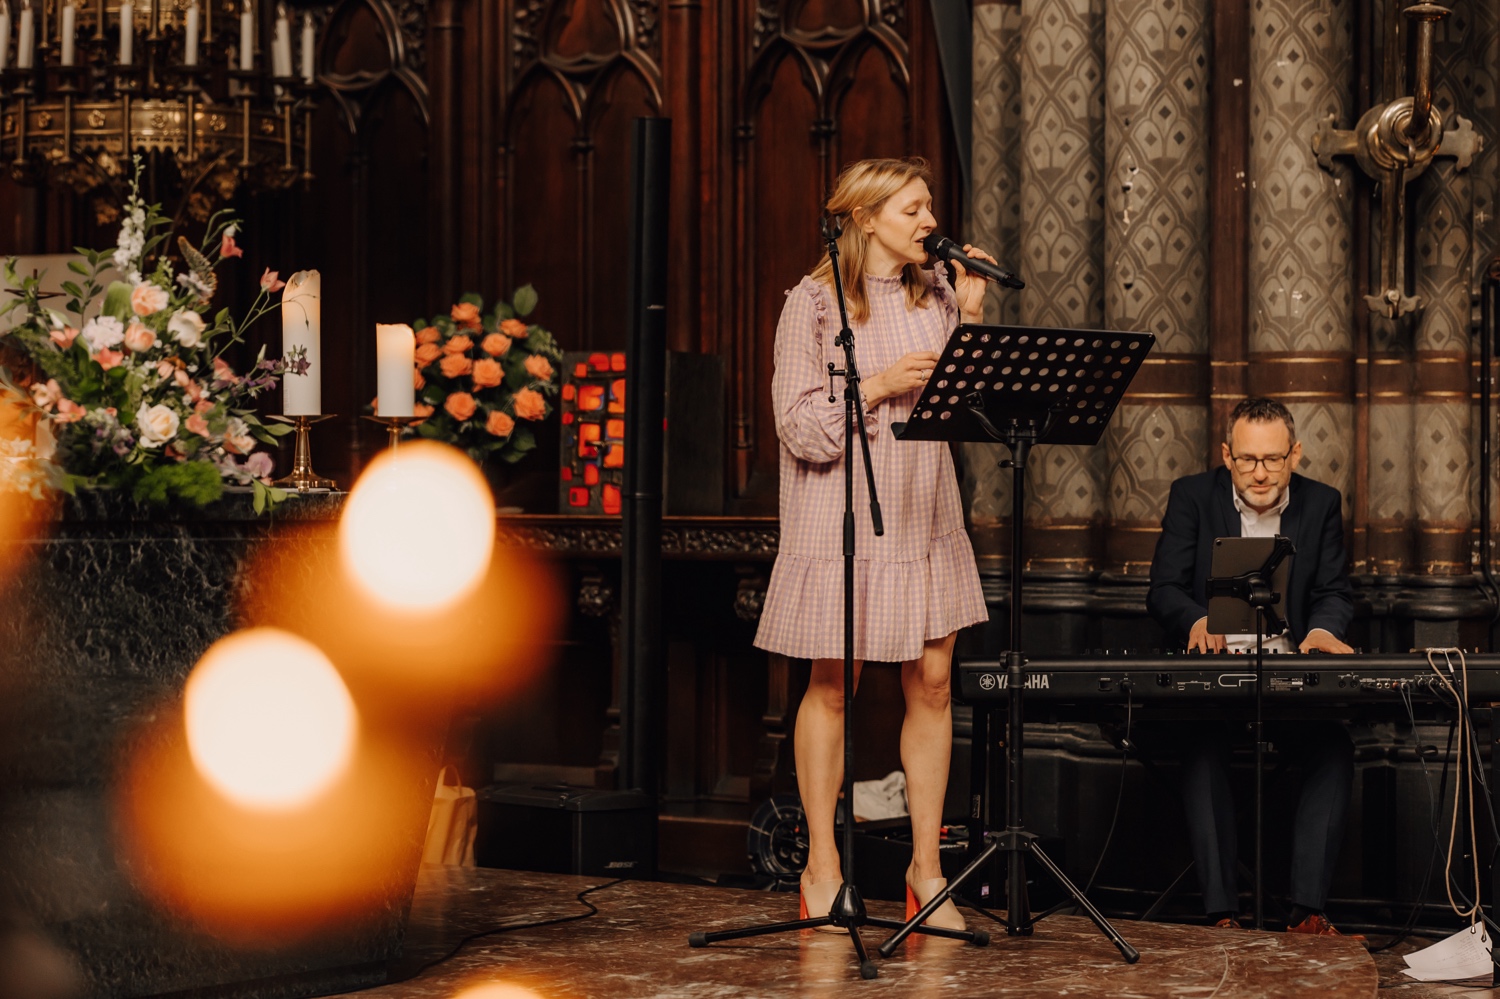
0, 164, 308, 512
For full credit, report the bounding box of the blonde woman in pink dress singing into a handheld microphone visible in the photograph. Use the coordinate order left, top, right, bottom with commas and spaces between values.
755, 159, 993, 932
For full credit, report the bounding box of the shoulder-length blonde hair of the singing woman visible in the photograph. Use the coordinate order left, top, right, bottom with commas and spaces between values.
813, 156, 933, 323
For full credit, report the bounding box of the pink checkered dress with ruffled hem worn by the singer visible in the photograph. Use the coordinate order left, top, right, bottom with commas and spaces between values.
755, 273, 989, 663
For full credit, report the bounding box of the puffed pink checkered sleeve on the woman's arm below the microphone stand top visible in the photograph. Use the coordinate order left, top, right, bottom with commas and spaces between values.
771, 278, 881, 464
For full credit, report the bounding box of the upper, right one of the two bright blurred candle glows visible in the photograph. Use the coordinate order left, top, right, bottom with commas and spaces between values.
339, 441, 495, 612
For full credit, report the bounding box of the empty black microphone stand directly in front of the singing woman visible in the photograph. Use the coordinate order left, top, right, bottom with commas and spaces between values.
687, 218, 990, 980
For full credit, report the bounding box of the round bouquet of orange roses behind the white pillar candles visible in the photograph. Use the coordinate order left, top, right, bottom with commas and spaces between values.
413, 285, 563, 465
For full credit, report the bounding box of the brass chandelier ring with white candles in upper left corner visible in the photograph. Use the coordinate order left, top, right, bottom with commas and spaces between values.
0, 0, 317, 218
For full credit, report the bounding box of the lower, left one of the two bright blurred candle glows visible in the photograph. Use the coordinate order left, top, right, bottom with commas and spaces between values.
183, 627, 357, 810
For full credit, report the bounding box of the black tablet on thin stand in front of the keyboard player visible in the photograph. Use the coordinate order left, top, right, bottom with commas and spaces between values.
1208, 534, 1298, 930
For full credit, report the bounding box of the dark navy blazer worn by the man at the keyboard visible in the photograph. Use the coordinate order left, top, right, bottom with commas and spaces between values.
1146, 465, 1355, 645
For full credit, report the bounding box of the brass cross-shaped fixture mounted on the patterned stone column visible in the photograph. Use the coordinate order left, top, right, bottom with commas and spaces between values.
1313, 3, 1482, 320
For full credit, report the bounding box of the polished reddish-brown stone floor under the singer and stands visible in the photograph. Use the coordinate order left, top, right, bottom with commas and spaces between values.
331, 869, 1380, 999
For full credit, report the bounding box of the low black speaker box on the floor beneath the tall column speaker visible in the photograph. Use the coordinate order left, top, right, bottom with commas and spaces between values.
474, 785, 656, 878
